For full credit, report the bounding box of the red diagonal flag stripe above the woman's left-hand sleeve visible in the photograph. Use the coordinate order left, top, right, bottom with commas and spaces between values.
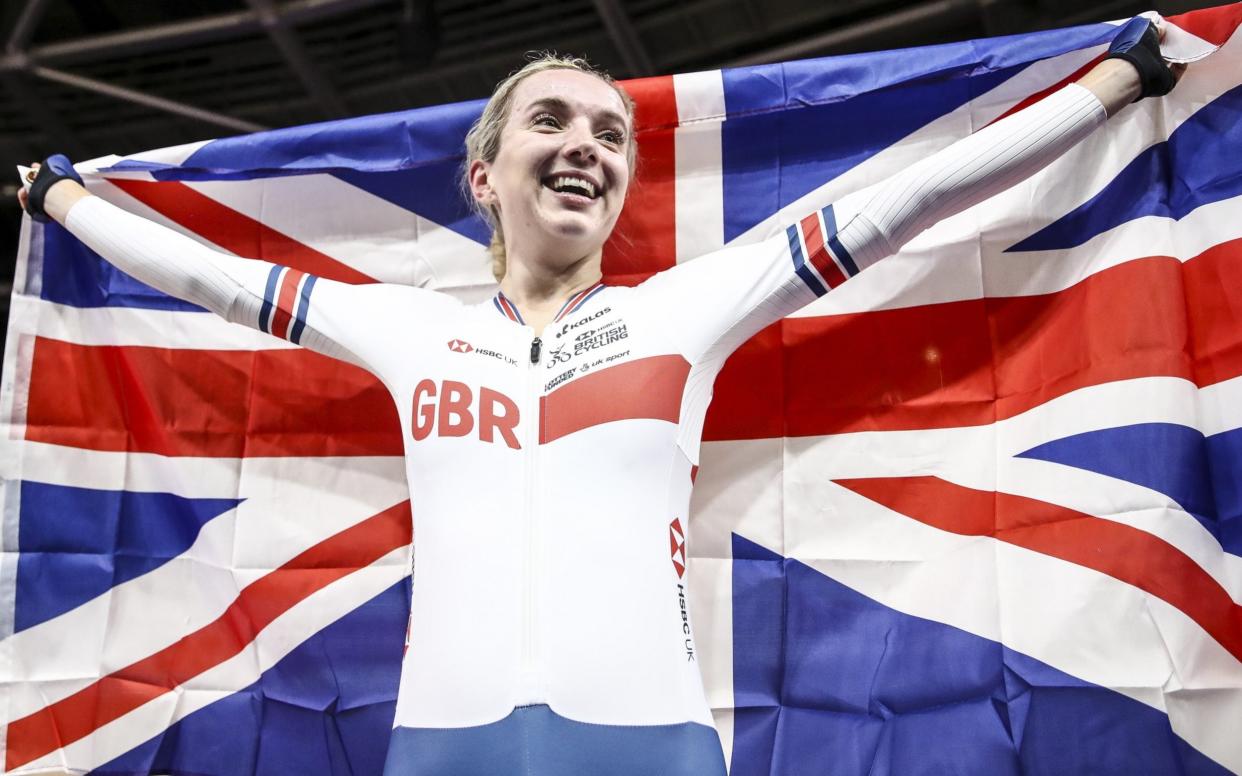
108, 178, 375, 283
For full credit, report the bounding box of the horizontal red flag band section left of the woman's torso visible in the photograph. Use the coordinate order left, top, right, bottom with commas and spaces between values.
26, 338, 402, 458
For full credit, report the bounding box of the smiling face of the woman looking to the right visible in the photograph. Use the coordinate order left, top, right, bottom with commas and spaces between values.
471, 70, 631, 269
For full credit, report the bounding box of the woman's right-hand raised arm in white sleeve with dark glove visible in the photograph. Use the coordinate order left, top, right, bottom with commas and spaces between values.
645, 17, 1181, 372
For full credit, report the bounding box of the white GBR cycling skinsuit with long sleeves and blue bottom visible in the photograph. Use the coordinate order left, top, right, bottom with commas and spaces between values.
55, 86, 1105, 776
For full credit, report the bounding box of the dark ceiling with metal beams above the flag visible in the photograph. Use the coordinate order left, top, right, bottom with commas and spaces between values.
0, 0, 1218, 332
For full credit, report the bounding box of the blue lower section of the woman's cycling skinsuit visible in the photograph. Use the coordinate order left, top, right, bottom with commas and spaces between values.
384, 705, 725, 776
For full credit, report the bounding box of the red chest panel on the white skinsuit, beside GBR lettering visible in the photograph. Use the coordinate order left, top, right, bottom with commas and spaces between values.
539, 355, 691, 444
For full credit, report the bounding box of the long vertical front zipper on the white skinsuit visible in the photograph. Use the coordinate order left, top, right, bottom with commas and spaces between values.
520, 336, 545, 704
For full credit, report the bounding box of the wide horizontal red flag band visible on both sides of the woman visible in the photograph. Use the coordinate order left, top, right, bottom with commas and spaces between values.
26, 240, 1242, 457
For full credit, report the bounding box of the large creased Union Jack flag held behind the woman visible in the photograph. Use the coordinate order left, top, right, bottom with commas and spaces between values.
0, 4, 1242, 776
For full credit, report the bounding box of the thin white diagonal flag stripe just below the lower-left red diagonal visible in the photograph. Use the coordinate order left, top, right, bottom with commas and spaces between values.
21, 549, 409, 772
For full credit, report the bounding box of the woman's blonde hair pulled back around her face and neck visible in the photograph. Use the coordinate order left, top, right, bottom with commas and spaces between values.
461, 51, 638, 281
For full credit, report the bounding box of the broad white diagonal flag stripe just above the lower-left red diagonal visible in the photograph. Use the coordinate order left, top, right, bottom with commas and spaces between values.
0, 474, 406, 721
